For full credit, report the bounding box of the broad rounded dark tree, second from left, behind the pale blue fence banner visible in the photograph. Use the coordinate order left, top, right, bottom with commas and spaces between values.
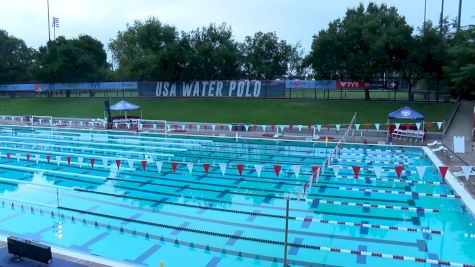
37, 35, 109, 82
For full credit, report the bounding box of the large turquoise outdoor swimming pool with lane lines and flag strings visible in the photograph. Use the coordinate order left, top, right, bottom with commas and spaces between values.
0, 127, 475, 267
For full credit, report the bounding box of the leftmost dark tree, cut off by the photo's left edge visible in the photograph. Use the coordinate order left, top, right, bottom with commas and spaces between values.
0, 30, 35, 83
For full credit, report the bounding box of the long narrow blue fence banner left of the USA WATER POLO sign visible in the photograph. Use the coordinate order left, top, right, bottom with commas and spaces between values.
0, 82, 137, 92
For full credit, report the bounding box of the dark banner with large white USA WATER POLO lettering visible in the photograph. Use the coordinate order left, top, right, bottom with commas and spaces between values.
138, 80, 285, 98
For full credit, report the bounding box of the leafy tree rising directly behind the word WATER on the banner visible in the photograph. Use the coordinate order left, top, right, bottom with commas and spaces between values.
181, 24, 240, 80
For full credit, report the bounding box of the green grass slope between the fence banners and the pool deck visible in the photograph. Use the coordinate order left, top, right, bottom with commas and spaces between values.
0, 98, 453, 124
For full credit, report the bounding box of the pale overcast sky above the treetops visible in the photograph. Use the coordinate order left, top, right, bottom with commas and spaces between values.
0, 0, 475, 57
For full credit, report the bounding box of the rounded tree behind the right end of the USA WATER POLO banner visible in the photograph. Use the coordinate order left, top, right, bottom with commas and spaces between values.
240, 32, 292, 79
